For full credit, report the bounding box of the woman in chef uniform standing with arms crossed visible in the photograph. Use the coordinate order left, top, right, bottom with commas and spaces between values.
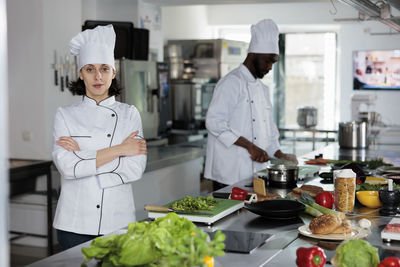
52, 25, 147, 249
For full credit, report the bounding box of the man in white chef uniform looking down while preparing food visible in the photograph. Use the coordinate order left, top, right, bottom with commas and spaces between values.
204, 19, 297, 190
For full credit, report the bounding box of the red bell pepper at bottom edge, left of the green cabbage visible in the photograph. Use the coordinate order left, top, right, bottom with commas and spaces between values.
296, 247, 326, 267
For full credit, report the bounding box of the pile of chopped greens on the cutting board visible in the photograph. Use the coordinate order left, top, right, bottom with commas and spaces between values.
171, 196, 217, 211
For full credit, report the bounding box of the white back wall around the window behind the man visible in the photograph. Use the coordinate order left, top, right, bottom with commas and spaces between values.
162, 2, 400, 125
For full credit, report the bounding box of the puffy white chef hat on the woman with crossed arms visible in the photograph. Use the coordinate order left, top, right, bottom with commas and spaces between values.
69, 24, 115, 70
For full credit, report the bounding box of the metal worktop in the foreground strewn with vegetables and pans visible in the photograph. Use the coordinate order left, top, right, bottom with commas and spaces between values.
29, 144, 400, 267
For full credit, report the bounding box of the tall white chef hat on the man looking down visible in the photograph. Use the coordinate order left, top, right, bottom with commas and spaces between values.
248, 19, 279, 54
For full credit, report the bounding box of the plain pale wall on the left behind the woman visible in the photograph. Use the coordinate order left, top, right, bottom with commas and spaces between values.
7, 0, 81, 159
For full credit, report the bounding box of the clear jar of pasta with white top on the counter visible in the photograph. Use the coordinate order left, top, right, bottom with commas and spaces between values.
335, 169, 356, 212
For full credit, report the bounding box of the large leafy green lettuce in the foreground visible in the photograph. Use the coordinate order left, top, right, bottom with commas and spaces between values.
82, 213, 225, 267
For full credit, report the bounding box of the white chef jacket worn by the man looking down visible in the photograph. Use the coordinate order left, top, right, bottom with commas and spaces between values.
204, 64, 280, 185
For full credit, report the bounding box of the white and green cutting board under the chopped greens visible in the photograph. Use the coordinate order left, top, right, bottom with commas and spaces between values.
148, 198, 244, 224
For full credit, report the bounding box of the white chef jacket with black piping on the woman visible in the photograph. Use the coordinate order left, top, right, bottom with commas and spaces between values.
52, 96, 146, 235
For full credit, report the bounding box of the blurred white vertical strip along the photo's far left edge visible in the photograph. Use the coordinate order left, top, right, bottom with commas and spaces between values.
0, 0, 10, 267
